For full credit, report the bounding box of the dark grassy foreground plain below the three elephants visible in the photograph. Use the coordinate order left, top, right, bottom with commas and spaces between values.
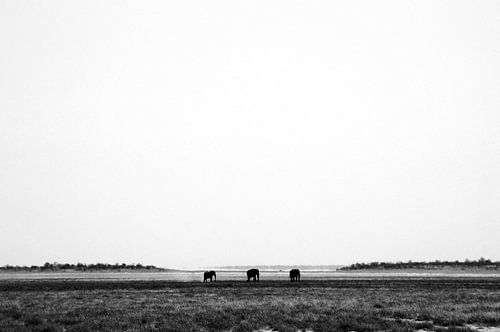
0, 277, 500, 331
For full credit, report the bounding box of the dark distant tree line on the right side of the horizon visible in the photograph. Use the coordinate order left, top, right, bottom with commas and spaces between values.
340, 258, 500, 271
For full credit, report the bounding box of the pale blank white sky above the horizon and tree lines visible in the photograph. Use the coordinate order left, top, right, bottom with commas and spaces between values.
0, 0, 500, 267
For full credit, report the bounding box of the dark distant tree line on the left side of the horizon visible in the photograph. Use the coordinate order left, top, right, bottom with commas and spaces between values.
0, 262, 164, 272
